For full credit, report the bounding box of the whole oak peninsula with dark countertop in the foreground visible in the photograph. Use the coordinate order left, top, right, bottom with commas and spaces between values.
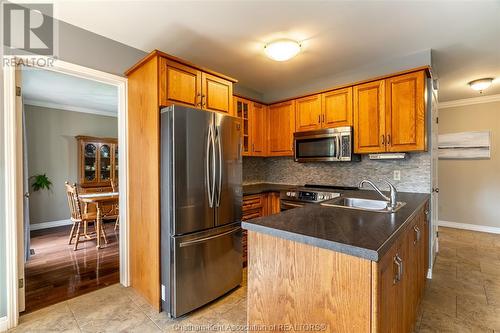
242, 191, 429, 333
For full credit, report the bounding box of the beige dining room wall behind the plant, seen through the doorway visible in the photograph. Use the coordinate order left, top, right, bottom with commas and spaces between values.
25, 105, 118, 224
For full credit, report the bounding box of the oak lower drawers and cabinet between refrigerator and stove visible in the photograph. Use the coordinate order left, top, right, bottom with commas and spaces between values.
241, 192, 280, 266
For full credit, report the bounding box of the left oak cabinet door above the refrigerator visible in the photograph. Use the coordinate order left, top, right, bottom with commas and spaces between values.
159, 58, 201, 108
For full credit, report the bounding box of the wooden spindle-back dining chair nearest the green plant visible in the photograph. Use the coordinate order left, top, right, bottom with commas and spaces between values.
65, 182, 97, 251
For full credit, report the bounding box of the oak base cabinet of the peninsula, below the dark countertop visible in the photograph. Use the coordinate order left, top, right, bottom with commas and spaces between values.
247, 201, 429, 333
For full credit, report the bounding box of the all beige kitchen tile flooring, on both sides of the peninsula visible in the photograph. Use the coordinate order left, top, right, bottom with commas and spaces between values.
12, 228, 500, 333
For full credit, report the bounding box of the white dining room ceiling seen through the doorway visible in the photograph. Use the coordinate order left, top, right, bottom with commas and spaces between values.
22, 68, 118, 116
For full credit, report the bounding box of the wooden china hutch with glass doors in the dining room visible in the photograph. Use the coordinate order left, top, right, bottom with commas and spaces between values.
76, 136, 118, 188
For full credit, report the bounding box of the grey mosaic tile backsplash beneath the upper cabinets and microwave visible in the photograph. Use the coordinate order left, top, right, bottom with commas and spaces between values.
243, 153, 431, 193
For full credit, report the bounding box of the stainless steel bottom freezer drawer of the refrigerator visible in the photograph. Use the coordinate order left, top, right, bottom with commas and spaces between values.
170, 223, 242, 318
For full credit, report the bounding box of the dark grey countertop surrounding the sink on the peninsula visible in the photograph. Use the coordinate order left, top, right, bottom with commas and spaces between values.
242, 190, 430, 261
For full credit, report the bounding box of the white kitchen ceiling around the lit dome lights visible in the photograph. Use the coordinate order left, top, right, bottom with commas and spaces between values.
50, 1, 500, 101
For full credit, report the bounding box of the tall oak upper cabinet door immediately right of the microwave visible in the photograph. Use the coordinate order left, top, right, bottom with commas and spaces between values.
353, 80, 385, 153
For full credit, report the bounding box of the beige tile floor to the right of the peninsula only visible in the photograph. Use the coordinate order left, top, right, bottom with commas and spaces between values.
416, 228, 500, 333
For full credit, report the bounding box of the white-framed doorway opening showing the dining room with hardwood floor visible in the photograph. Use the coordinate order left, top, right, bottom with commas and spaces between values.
19, 66, 120, 314
